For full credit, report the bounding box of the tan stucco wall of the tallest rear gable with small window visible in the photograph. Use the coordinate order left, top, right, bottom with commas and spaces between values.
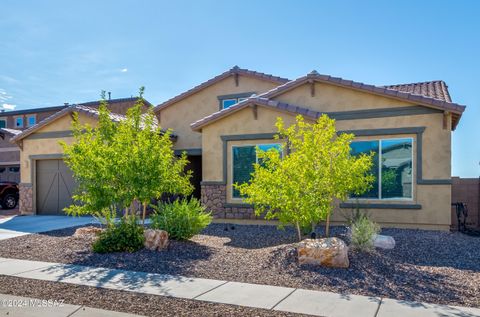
157, 76, 278, 150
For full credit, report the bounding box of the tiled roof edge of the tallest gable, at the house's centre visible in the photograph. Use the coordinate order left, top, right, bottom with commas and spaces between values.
154, 66, 289, 111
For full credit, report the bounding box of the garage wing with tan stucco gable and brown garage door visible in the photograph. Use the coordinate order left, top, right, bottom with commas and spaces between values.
10, 97, 152, 214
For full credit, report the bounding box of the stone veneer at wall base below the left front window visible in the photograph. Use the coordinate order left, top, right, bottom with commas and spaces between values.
201, 183, 262, 219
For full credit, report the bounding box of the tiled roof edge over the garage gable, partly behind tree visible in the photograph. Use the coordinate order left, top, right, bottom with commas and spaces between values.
10, 105, 167, 142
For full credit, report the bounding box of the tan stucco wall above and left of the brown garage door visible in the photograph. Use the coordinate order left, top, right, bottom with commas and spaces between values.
20, 113, 97, 183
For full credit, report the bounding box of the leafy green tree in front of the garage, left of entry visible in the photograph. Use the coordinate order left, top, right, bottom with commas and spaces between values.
62, 88, 192, 223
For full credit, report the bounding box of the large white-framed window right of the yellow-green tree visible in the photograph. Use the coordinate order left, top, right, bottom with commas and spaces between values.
351, 138, 413, 199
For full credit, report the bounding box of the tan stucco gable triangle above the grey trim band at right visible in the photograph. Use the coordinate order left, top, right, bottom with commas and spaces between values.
278, 83, 414, 112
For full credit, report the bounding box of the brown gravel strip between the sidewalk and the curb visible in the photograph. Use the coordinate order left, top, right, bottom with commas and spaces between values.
0, 275, 304, 317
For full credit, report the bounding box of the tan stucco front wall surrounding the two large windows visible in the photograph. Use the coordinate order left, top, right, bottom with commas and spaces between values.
202, 90, 451, 230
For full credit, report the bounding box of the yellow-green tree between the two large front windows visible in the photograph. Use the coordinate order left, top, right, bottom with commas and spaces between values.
234, 115, 374, 240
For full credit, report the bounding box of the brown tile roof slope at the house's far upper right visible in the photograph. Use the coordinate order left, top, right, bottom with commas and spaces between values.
383, 80, 452, 103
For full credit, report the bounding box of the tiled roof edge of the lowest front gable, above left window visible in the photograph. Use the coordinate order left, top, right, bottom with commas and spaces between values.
190, 97, 323, 131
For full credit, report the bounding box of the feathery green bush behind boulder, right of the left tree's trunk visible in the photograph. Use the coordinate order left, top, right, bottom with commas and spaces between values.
151, 198, 212, 240
